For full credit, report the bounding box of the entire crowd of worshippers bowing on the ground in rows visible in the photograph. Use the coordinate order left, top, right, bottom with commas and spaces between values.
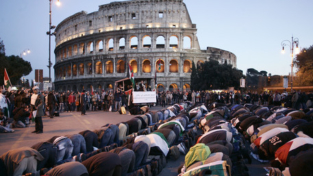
0, 99, 313, 176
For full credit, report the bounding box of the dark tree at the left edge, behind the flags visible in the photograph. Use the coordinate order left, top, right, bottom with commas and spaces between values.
0, 41, 32, 85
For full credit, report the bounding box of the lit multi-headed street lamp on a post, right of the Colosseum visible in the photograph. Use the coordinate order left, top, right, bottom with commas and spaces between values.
281, 36, 300, 92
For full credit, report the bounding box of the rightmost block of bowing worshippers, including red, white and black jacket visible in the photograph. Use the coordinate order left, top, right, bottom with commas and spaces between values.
230, 104, 313, 176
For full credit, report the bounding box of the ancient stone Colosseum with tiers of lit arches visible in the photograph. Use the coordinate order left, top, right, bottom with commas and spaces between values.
54, 0, 237, 91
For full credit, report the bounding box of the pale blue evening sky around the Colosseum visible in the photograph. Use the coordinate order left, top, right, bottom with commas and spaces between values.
0, 0, 313, 80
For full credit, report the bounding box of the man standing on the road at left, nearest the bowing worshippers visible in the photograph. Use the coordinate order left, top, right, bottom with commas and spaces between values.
30, 86, 44, 134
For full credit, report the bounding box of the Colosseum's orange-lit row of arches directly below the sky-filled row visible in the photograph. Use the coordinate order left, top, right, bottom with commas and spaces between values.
55, 59, 192, 79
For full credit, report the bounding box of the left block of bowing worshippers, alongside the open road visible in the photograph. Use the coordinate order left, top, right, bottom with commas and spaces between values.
0, 102, 200, 176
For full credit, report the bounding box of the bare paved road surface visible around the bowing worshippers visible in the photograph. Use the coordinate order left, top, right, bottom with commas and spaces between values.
0, 107, 268, 176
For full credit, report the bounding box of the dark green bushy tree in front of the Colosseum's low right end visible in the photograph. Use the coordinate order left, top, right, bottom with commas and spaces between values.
191, 60, 243, 90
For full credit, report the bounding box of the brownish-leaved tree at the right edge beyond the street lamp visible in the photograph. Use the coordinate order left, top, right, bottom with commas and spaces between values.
295, 45, 313, 85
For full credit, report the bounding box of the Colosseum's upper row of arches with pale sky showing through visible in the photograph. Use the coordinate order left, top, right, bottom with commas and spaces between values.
56, 35, 192, 61
